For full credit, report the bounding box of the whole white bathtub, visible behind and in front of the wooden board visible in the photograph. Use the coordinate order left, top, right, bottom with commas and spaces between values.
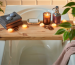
2, 5, 69, 65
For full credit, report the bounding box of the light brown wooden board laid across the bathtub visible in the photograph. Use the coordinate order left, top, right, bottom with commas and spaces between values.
0, 21, 72, 40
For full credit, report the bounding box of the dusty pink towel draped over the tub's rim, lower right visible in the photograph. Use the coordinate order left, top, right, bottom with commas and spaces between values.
53, 41, 75, 65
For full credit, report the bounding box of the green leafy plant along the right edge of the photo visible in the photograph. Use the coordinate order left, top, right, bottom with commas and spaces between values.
55, 2, 75, 42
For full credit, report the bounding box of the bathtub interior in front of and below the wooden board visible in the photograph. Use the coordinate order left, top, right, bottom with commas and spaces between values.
2, 40, 62, 65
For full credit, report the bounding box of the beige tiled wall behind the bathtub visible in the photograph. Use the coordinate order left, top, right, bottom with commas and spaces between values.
0, 0, 75, 20
